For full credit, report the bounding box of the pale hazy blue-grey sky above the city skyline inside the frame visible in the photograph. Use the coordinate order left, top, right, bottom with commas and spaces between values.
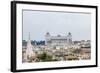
23, 10, 91, 40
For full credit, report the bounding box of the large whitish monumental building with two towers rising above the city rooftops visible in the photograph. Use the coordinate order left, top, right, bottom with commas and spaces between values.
45, 32, 72, 47
